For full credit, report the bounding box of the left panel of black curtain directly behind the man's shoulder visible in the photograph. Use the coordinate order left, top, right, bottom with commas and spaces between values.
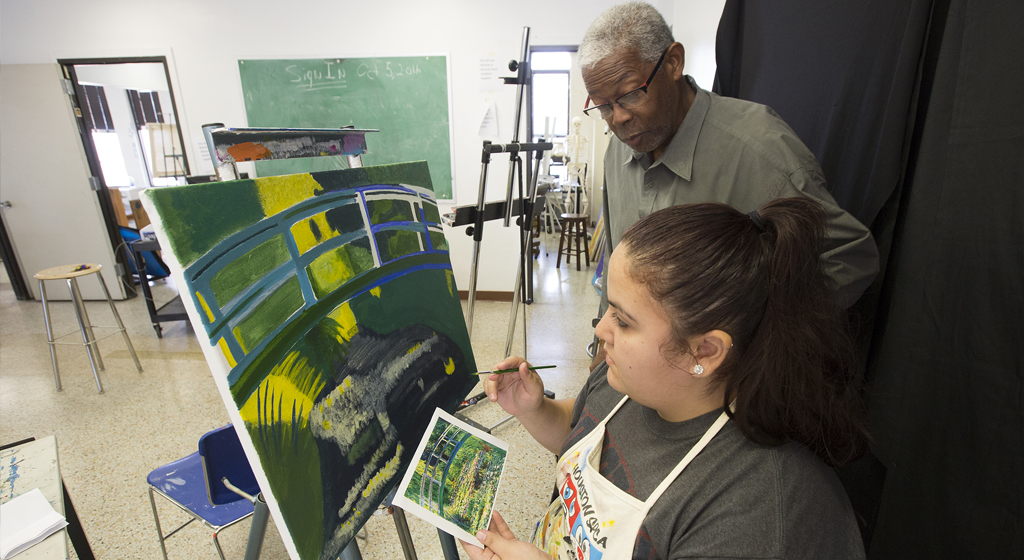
716, 0, 932, 230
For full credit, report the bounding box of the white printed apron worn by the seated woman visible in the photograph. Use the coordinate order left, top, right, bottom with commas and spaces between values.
531, 396, 729, 560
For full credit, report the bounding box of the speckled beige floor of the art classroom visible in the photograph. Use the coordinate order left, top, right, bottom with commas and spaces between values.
0, 236, 598, 560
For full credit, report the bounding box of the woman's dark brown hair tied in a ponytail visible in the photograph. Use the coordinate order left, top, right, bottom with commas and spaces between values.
621, 198, 866, 465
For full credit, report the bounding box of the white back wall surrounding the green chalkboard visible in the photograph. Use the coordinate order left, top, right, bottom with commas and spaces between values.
0, 0, 716, 291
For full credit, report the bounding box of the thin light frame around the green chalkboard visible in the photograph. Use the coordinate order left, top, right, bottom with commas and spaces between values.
237, 51, 458, 205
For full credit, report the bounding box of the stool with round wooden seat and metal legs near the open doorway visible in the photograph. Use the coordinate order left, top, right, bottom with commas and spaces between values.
35, 263, 142, 393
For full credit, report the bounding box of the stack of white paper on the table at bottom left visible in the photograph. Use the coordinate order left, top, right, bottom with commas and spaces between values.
0, 488, 68, 560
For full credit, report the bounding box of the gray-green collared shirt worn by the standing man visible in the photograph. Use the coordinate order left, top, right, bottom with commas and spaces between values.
601, 76, 879, 311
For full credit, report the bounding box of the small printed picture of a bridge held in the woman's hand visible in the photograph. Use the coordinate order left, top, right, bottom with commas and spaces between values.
392, 408, 508, 543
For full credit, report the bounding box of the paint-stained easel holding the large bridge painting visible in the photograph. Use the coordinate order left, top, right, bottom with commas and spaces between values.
203, 123, 450, 560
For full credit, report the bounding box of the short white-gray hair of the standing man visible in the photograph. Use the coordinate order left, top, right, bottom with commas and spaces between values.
577, 2, 675, 70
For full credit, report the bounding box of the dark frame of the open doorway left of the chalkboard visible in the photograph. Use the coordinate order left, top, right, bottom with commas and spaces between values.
57, 56, 190, 297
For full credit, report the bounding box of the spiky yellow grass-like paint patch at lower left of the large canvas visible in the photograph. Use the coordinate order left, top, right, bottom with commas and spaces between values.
239, 352, 324, 427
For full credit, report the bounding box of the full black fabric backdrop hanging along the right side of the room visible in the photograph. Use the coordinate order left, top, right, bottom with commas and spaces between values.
716, 0, 1024, 560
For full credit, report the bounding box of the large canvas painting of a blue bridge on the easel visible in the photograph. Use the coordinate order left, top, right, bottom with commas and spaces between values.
143, 162, 476, 560
